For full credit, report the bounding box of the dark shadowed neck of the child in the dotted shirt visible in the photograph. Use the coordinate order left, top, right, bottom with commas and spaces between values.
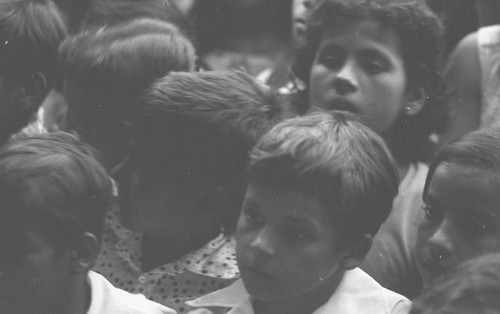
142, 217, 221, 271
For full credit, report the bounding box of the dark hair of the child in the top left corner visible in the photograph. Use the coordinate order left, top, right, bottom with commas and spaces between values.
0, 0, 66, 89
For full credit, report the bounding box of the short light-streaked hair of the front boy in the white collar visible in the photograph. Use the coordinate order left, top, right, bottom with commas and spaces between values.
248, 111, 399, 245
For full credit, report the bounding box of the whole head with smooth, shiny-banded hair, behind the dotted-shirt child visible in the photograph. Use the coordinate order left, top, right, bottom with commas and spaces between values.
60, 19, 195, 168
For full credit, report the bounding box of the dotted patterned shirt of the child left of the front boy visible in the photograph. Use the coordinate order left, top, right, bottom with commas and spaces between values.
94, 206, 239, 313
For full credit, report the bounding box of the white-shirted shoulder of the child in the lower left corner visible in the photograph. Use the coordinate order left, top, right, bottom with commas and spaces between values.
87, 271, 175, 314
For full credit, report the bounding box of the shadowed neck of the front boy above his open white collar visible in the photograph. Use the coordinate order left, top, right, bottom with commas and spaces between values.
252, 272, 345, 314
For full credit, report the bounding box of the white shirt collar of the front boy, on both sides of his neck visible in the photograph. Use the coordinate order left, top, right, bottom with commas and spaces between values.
186, 268, 411, 314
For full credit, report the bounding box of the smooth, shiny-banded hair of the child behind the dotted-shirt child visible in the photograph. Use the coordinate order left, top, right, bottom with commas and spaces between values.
59, 19, 195, 115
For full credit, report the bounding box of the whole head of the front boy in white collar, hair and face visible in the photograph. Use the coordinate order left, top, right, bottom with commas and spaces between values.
236, 113, 398, 304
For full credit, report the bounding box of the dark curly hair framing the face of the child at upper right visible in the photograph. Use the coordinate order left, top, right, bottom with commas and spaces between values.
294, 0, 447, 161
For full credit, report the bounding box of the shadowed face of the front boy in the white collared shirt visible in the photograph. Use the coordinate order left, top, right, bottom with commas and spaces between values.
236, 183, 349, 302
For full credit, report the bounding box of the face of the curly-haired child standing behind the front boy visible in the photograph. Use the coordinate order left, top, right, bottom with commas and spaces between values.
309, 18, 407, 135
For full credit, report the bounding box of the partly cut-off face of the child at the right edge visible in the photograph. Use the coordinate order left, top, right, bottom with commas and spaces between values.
417, 162, 500, 286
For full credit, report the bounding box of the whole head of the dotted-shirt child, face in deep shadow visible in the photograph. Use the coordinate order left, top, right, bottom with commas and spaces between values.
117, 72, 288, 235
